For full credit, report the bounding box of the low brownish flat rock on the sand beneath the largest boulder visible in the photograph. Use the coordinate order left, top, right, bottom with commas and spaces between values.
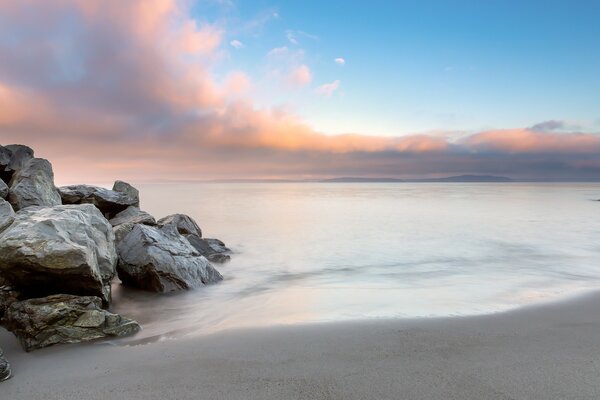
5, 294, 140, 351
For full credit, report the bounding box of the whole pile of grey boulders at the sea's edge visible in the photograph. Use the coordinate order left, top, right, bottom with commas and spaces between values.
0, 145, 229, 356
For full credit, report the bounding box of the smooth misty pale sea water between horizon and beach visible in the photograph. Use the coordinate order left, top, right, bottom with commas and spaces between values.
115, 183, 600, 339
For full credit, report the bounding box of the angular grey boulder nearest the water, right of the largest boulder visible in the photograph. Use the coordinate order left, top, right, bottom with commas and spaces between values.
117, 225, 223, 293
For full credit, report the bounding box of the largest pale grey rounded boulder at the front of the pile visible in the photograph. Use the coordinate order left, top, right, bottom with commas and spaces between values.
0, 204, 117, 304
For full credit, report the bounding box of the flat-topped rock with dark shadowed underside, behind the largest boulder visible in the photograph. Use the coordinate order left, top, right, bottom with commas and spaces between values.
58, 185, 139, 219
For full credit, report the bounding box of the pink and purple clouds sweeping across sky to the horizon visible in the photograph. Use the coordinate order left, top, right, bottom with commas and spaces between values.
0, 0, 600, 183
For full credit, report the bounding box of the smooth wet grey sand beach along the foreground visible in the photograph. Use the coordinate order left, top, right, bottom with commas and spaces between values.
0, 293, 600, 400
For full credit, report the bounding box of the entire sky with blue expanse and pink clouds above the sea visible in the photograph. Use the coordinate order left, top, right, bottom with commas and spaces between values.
0, 0, 600, 183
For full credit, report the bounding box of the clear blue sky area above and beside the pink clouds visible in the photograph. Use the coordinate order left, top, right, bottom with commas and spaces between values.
194, 0, 600, 135
